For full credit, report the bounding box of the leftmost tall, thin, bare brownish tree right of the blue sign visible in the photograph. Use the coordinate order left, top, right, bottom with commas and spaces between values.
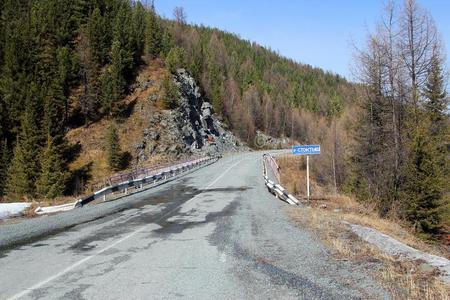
349, 37, 394, 216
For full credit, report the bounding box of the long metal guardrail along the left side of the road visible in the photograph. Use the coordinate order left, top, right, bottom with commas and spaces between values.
75, 156, 219, 207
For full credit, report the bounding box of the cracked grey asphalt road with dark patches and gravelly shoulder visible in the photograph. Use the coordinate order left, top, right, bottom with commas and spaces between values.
0, 153, 387, 299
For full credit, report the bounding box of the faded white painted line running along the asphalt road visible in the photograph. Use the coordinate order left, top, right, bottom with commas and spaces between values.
8, 159, 242, 300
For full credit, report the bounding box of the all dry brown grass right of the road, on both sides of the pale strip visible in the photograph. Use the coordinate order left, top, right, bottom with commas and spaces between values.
277, 157, 450, 299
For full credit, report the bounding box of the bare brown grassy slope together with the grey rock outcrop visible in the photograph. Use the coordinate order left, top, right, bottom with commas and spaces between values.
66, 60, 246, 193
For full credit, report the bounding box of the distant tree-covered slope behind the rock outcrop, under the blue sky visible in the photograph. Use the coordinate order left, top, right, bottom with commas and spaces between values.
165, 21, 357, 144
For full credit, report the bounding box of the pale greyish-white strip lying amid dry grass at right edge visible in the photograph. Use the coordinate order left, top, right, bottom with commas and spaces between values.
344, 222, 450, 283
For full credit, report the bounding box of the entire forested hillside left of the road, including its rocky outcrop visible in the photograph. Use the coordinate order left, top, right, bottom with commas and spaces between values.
0, 0, 353, 200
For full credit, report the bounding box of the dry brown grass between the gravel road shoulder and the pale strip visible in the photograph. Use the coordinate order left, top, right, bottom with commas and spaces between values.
286, 207, 450, 300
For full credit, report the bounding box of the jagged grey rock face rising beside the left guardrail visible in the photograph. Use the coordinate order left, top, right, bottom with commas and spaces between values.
134, 69, 248, 161
